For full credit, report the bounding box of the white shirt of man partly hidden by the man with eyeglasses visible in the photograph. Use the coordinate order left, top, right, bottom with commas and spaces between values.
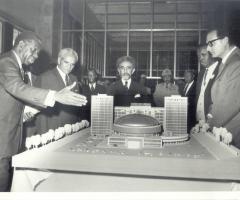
196, 62, 218, 121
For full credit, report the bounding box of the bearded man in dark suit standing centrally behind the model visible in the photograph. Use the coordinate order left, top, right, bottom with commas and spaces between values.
107, 56, 151, 106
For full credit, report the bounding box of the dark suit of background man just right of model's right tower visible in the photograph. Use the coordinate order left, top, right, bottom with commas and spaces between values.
183, 81, 196, 133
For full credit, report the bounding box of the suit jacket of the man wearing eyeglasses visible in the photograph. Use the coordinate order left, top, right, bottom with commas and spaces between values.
210, 48, 240, 148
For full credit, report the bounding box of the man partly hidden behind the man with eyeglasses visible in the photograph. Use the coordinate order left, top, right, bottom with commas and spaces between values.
196, 44, 218, 121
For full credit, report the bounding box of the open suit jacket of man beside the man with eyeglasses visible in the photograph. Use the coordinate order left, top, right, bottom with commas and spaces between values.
196, 63, 218, 119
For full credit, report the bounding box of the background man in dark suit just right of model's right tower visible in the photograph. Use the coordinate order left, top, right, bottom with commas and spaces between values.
182, 70, 196, 133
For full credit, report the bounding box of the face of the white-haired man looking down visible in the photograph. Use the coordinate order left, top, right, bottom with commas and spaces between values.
58, 56, 76, 74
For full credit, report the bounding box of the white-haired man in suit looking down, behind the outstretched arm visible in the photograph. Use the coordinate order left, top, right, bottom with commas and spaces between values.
32, 48, 82, 134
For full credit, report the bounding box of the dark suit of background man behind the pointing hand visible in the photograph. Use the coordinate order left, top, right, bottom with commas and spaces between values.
81, 83, 106, 122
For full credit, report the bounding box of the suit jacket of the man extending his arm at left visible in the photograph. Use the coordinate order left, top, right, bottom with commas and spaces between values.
0, 51, 48, 158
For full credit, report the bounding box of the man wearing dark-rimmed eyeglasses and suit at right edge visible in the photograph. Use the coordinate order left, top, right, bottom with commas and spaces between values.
206, 29, 240, 148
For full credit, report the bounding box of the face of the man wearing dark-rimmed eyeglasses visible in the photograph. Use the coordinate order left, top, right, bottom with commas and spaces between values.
206, 31, 228, 58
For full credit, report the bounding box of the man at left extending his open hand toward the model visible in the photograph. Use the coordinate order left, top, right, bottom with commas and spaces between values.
0, 32, 86, 191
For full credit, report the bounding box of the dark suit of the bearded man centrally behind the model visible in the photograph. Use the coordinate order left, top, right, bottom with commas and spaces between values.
107, 80, 151, 106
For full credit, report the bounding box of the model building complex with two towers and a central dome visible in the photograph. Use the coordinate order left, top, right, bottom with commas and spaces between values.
91, 95, 189, 148
